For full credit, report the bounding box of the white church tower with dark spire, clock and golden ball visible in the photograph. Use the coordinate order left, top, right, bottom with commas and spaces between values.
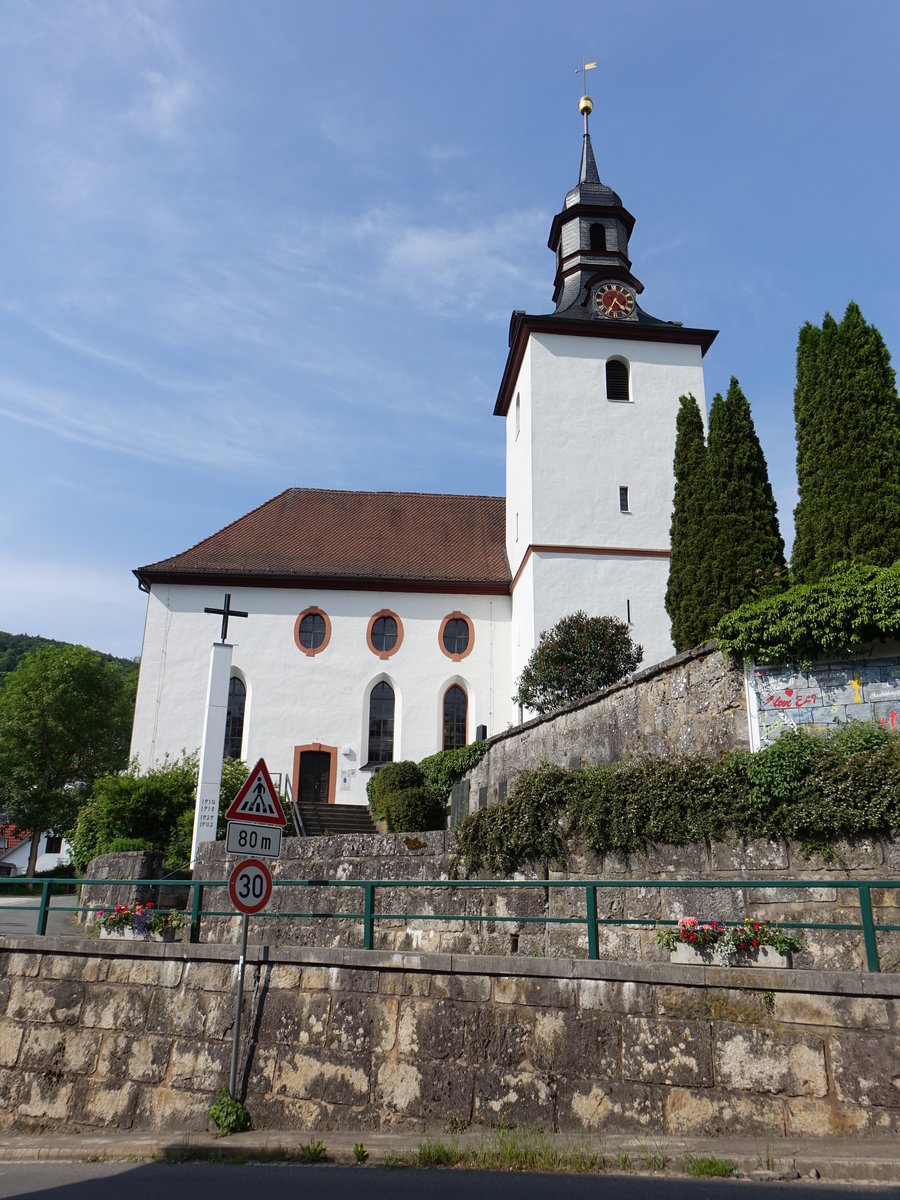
494, 96, 716, 696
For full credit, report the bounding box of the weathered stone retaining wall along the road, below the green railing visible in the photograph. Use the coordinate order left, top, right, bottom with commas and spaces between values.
0, 937, 900, 1140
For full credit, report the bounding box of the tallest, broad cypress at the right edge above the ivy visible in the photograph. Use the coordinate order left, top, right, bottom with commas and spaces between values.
791, 301, 900, 583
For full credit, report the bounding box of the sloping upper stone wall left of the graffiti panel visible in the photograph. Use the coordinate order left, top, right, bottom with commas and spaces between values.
467, 642, 750, 811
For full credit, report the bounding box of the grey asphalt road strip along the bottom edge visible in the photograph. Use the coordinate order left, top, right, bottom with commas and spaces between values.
0, 1163, 896, 1200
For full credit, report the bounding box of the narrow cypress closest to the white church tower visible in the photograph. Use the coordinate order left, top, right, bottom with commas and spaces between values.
666, 396, 709, 653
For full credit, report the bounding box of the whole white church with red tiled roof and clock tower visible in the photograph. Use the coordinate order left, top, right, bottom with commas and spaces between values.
131, 97, 715, 804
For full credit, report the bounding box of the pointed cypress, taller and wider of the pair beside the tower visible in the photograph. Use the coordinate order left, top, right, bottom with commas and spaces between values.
704, 376, 787, 619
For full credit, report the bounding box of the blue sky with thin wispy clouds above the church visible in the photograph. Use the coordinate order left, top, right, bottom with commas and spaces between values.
0, 0, 900, 655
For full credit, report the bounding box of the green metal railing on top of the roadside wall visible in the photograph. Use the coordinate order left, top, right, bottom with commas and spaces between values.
0, 877, 900, 972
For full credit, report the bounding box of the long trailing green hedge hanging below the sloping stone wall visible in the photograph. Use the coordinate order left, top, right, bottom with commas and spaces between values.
455, 725, 900, 872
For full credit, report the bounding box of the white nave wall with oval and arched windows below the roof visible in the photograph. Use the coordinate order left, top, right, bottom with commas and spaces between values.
132, 583, 512, 804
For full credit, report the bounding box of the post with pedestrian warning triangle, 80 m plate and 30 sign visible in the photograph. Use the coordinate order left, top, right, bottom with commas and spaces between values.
226, 758, 286, 1099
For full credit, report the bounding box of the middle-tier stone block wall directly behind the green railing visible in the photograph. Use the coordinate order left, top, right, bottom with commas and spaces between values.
197, 832, 900, 971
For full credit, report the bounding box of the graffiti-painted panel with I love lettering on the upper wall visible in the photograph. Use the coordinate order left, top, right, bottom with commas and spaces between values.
746, 654, 900, 749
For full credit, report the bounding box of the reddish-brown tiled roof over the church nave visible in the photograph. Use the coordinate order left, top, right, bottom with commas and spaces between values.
134, 487, 510, 592
